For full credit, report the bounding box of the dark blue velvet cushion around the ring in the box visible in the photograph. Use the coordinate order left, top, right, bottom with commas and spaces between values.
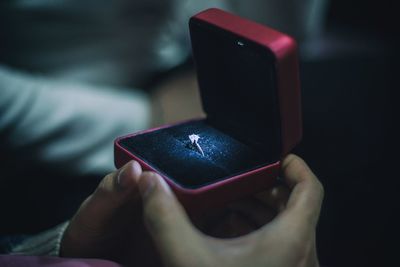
121, 119, 276, 188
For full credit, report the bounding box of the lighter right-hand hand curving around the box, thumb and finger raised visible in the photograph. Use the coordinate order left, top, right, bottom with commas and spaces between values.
139, 155, 323, 267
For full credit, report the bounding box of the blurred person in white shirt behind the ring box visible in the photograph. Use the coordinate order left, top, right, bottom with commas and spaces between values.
0, 0, 327, 266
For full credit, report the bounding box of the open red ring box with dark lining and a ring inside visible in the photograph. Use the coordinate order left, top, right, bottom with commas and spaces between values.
114, 8, 302, 217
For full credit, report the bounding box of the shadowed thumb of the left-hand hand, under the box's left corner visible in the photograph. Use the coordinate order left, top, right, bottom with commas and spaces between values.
60, 161, 142, 257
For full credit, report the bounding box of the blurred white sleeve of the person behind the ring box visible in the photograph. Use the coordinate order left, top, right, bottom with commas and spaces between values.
0, 65, 150, 178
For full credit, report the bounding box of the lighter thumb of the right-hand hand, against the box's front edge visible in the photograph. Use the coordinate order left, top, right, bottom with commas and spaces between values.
139, 172, 200, 259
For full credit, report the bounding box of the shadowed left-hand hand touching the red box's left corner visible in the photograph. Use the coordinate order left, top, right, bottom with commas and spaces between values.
60, 161, 161, 266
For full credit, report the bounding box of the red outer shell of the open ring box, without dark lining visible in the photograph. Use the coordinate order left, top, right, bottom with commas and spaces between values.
114, 9, 302, 214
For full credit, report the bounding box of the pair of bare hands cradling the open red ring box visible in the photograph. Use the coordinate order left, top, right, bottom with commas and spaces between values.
61, 155, 323, 267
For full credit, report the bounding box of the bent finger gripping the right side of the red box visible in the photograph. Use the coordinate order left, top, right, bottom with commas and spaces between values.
281, 155, 324, 226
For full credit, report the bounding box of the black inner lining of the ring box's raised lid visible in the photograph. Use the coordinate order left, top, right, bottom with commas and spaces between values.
190, 18, 282, 159
